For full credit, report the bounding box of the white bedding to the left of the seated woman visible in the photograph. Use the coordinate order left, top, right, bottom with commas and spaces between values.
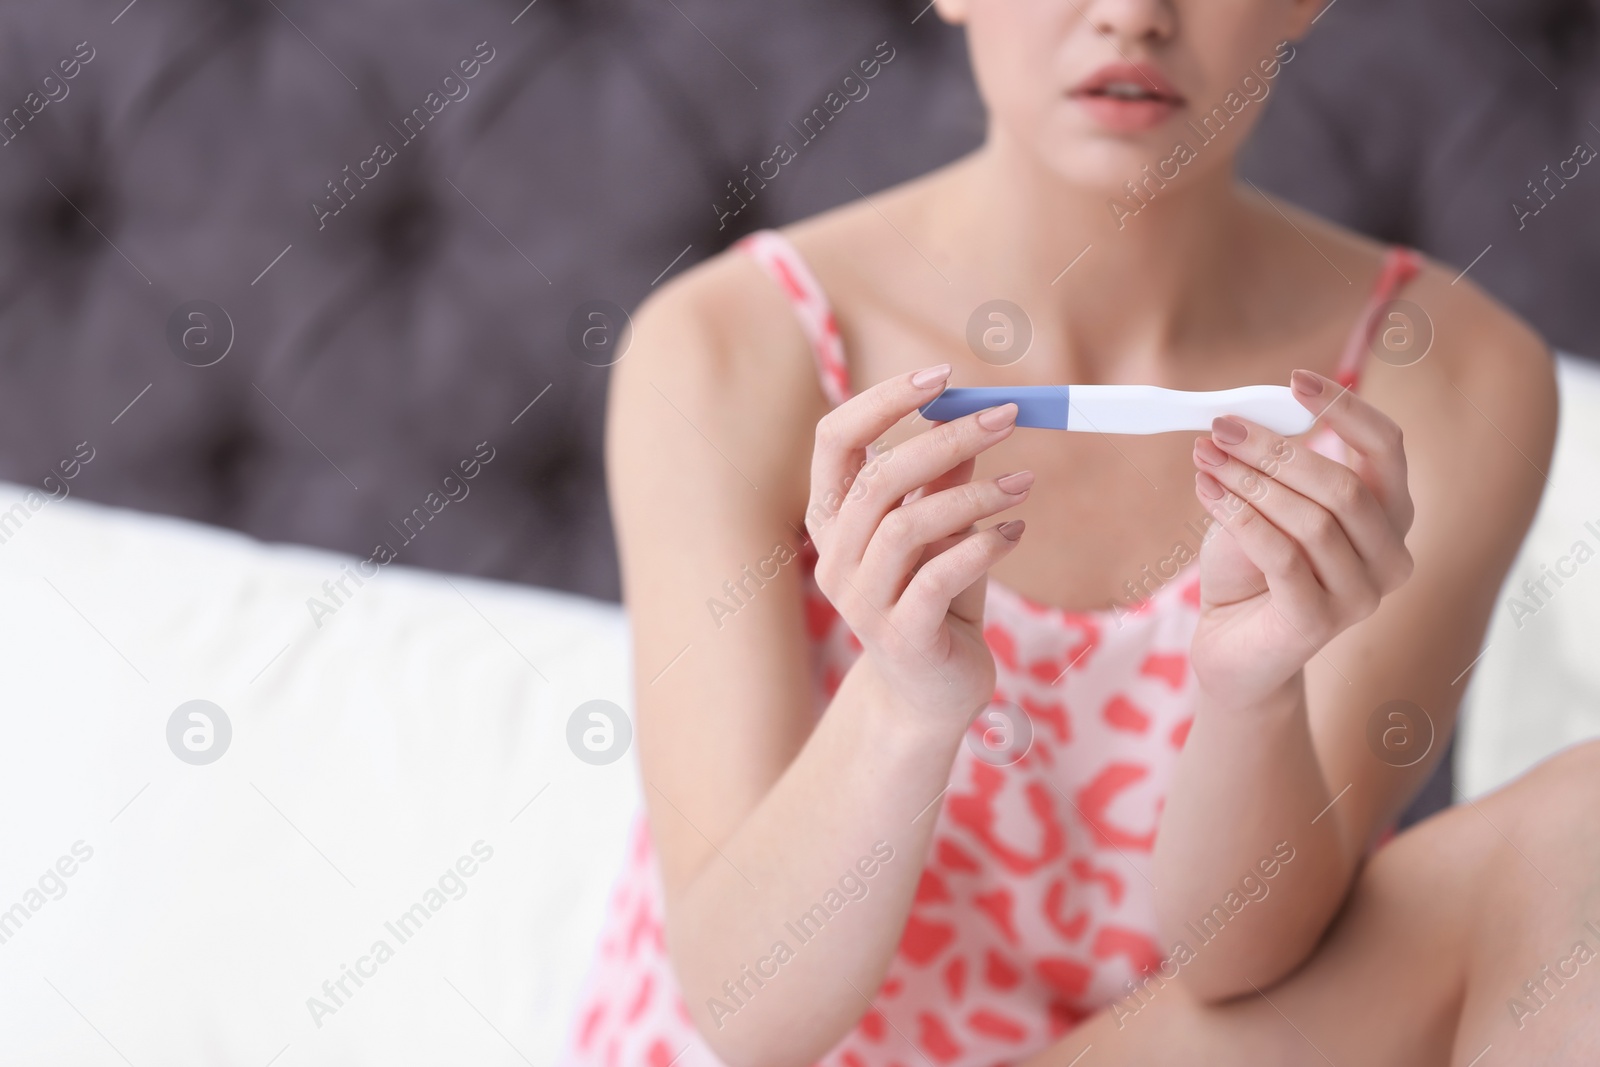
0, 483, 638, 1067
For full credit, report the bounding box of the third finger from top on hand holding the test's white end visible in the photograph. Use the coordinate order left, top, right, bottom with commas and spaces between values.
1194, 437, 1379, 607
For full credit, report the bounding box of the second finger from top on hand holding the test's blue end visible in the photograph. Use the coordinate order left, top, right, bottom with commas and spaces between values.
829, 403, 1016, 560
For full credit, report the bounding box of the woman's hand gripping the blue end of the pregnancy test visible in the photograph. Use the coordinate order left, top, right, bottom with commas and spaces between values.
806, 365, 1034, 733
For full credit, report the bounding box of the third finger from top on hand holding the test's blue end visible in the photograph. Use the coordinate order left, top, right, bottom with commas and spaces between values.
854, 470, 1034, 605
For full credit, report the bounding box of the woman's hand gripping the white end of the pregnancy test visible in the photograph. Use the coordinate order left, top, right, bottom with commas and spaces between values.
1190, 371, 1414, 705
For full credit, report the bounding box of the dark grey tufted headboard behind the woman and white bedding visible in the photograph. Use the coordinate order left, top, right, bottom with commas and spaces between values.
0, 0, 1600, 598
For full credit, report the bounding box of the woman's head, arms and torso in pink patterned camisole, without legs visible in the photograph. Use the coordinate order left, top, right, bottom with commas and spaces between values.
560, 0, 1555, 1067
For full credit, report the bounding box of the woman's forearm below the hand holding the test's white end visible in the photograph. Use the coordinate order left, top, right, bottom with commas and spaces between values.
1155, 677, 1357, 998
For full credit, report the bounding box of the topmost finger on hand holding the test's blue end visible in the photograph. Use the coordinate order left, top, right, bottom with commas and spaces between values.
806, 363, 950, 537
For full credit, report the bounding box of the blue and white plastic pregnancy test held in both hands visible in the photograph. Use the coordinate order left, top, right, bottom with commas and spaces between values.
920, 386, 1314, 437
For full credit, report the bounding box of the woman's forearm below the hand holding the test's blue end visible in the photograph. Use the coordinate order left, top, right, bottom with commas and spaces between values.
667, 659, 960, 1067
